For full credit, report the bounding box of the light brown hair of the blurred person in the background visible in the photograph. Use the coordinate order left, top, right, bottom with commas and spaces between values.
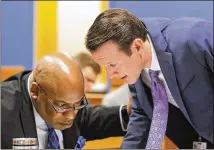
74, 52, 101, 74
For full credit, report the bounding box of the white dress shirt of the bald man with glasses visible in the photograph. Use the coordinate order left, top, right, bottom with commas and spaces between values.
28, 78, 64, 149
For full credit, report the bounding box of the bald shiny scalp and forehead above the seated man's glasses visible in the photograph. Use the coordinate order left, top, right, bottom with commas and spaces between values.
32, 53, 84, 104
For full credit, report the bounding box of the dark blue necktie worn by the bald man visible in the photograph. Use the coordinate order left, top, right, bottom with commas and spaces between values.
47, 125, 60, 149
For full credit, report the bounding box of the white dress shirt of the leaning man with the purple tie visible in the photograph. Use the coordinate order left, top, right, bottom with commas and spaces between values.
141, 36, 179, 108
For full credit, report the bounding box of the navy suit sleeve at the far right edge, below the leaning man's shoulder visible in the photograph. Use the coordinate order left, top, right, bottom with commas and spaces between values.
188, 21, 214, 72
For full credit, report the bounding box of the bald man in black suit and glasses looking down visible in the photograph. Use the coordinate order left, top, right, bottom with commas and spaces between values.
1, 53, 128, 149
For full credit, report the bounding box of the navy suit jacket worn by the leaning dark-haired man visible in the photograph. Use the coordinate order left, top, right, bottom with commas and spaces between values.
121, 18, 214, 148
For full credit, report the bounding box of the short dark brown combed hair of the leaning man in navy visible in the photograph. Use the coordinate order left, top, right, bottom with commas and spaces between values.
85, 9, 147, 55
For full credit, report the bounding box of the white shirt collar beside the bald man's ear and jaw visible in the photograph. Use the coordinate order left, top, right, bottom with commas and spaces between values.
27, 76, 47, 130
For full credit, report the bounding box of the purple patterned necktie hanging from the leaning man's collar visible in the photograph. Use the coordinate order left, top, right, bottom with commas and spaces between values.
146, 70, 168, 149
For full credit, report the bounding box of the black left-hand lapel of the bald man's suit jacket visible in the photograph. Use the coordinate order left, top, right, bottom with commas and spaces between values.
20, 74, 37, 137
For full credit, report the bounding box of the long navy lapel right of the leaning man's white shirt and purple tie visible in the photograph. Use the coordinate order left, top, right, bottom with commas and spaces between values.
144, 20, 192, 123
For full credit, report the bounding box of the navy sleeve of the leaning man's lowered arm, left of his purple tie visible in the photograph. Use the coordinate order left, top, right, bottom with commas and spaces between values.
121, 85, 151, 149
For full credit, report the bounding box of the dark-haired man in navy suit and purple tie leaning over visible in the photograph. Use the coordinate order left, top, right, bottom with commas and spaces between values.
85, 9, 214, 149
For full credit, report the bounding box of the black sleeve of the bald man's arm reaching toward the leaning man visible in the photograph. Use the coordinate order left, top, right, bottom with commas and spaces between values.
80, 105, 126, 140
